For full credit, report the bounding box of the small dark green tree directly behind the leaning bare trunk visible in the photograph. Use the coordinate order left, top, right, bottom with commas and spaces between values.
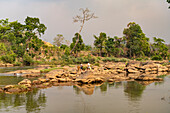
70, 33, 85, 55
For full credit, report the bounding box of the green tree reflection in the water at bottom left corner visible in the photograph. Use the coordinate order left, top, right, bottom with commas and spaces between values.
0, 89, 46, 113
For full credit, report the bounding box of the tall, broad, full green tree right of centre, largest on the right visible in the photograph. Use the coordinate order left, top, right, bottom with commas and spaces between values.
123, 22, 150, 58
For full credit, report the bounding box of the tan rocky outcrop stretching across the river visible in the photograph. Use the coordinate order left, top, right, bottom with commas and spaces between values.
0, 61, 170, 93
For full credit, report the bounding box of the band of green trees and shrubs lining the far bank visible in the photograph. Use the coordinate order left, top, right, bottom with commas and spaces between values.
0, 17, 170, 65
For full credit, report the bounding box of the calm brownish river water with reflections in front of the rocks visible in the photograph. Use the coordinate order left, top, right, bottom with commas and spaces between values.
0, 76, 170, 113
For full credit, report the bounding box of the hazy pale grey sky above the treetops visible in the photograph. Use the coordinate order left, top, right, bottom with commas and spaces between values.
0, 0, 170, 45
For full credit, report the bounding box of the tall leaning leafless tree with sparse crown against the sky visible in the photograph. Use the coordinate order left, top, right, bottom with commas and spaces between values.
70, 8, 97, 54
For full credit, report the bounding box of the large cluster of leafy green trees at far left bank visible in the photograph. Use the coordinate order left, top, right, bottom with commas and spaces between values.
0, 17, 47, 63
